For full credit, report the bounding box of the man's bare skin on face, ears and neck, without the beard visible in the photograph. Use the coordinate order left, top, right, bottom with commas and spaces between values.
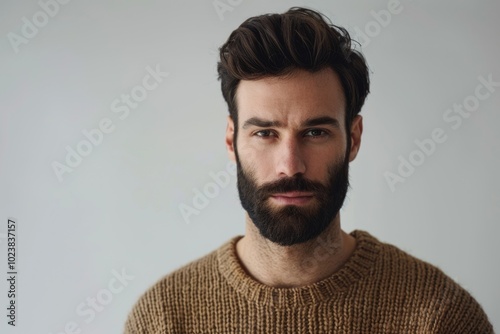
226, 68, 363, 288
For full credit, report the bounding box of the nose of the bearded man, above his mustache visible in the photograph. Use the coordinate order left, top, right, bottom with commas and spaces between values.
276, 138, 306, 177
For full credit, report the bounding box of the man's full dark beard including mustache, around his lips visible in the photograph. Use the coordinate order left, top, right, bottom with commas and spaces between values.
236, 146, 349, 246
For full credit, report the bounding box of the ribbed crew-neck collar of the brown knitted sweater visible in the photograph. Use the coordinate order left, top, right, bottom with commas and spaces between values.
217, 230, 380, 308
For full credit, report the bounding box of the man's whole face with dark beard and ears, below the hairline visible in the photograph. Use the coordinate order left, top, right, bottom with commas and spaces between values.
226, 68, 361, 246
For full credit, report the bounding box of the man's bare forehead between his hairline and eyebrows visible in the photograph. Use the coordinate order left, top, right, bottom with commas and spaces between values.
236, 68, 345, 126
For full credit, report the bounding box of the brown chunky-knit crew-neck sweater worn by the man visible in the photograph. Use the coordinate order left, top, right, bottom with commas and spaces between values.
125, 231, 493, 334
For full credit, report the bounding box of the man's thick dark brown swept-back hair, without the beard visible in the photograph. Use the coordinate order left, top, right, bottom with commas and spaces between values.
217, 7, 370, 135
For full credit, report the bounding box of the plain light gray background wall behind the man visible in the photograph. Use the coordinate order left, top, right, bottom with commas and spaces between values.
0, 0, 500, 334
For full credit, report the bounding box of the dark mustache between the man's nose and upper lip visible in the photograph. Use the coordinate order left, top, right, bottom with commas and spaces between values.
257, 175, 327, 198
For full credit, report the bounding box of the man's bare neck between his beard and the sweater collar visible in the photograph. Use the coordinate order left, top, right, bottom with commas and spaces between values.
236, 214, 355, 288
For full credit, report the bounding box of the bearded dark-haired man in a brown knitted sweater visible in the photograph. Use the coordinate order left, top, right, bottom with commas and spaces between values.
126, 8, 493, 334
